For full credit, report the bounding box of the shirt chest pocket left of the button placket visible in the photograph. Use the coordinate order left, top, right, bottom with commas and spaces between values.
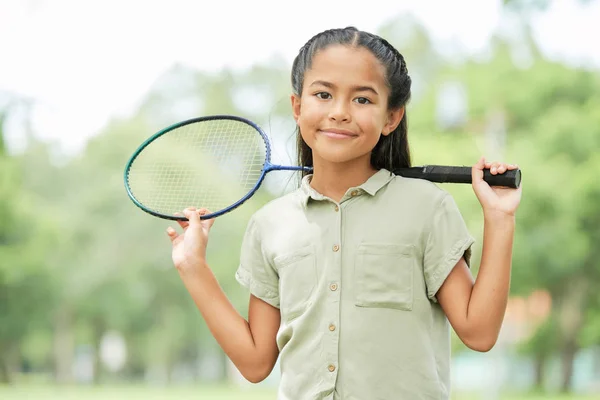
273, 246, 317, 322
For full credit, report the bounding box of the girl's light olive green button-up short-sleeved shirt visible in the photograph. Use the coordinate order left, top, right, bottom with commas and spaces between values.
236, 169, 474, 400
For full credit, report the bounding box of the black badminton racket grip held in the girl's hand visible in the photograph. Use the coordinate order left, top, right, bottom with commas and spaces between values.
394, 165, 521, 189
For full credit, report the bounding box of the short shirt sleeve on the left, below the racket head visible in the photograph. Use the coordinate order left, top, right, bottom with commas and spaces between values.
235, 218, 279, 308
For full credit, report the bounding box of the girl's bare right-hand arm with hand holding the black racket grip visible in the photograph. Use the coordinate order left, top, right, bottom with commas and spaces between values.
436, 160, 521, 351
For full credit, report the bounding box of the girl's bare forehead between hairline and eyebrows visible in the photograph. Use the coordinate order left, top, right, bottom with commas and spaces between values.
304, 45, 386, 90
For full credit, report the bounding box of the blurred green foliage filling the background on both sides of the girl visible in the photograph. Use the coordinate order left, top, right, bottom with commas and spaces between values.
0, 14, 600, 392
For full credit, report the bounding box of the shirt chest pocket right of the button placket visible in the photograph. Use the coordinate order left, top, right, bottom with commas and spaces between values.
354, 243, 415, 311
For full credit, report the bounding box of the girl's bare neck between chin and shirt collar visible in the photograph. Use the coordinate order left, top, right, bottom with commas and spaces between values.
310, 155, 377, 202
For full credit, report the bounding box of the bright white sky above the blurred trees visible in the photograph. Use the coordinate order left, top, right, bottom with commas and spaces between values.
0, 0, 600, 154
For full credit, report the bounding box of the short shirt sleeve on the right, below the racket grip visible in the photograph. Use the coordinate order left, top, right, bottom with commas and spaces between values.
423, 193, 475, 302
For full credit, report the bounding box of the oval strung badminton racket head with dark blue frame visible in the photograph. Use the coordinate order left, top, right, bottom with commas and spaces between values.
123, 115, 271, 221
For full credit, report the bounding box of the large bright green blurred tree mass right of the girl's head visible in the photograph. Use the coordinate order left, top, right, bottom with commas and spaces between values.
409, 22, 600, 391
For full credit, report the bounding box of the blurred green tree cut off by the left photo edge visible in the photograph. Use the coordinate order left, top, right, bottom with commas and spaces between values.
0, 114, 52, 383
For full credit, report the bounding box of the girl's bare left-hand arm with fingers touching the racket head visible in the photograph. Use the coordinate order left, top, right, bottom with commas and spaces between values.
168, 210, 280, 383
